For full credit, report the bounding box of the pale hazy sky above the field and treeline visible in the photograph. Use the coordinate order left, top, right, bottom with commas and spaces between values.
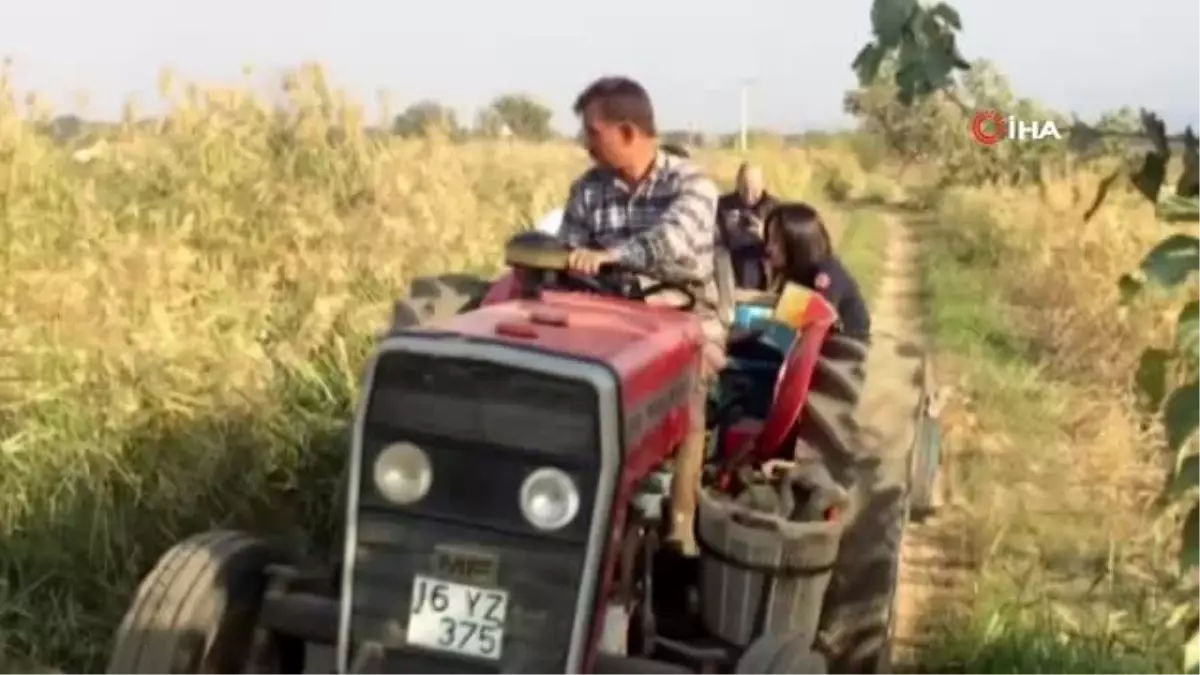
0, 0, 1200, 131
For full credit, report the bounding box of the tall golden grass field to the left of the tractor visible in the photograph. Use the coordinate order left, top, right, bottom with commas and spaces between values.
0, 63, 862, 673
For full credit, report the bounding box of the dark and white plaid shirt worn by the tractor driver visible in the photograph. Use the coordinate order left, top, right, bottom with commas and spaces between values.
559, 151, 725, 344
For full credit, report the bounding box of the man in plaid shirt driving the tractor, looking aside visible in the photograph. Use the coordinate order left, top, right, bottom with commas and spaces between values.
558, 77, 727, 555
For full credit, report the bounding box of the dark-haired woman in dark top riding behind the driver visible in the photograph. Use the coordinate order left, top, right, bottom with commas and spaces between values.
766, 203, 871, 341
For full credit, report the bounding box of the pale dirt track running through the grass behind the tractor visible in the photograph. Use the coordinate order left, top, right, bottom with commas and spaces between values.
860, 214, 964, 664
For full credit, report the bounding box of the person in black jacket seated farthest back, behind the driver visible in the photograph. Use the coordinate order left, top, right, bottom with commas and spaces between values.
716, 162, 779, 291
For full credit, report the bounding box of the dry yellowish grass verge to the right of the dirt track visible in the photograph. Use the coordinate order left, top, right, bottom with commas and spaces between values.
924, 162, 1183, 674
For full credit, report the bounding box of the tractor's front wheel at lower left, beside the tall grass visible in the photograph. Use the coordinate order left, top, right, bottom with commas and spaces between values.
107, 531, 289, 675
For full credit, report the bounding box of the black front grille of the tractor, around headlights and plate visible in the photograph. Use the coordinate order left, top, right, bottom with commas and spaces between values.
350, 352, 604, 675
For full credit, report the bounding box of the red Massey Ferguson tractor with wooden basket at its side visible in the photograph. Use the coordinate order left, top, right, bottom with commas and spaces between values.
108, 232, 926, 675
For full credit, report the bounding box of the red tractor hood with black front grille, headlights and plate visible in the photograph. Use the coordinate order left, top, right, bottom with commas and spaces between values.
338, 293, 702, 675
